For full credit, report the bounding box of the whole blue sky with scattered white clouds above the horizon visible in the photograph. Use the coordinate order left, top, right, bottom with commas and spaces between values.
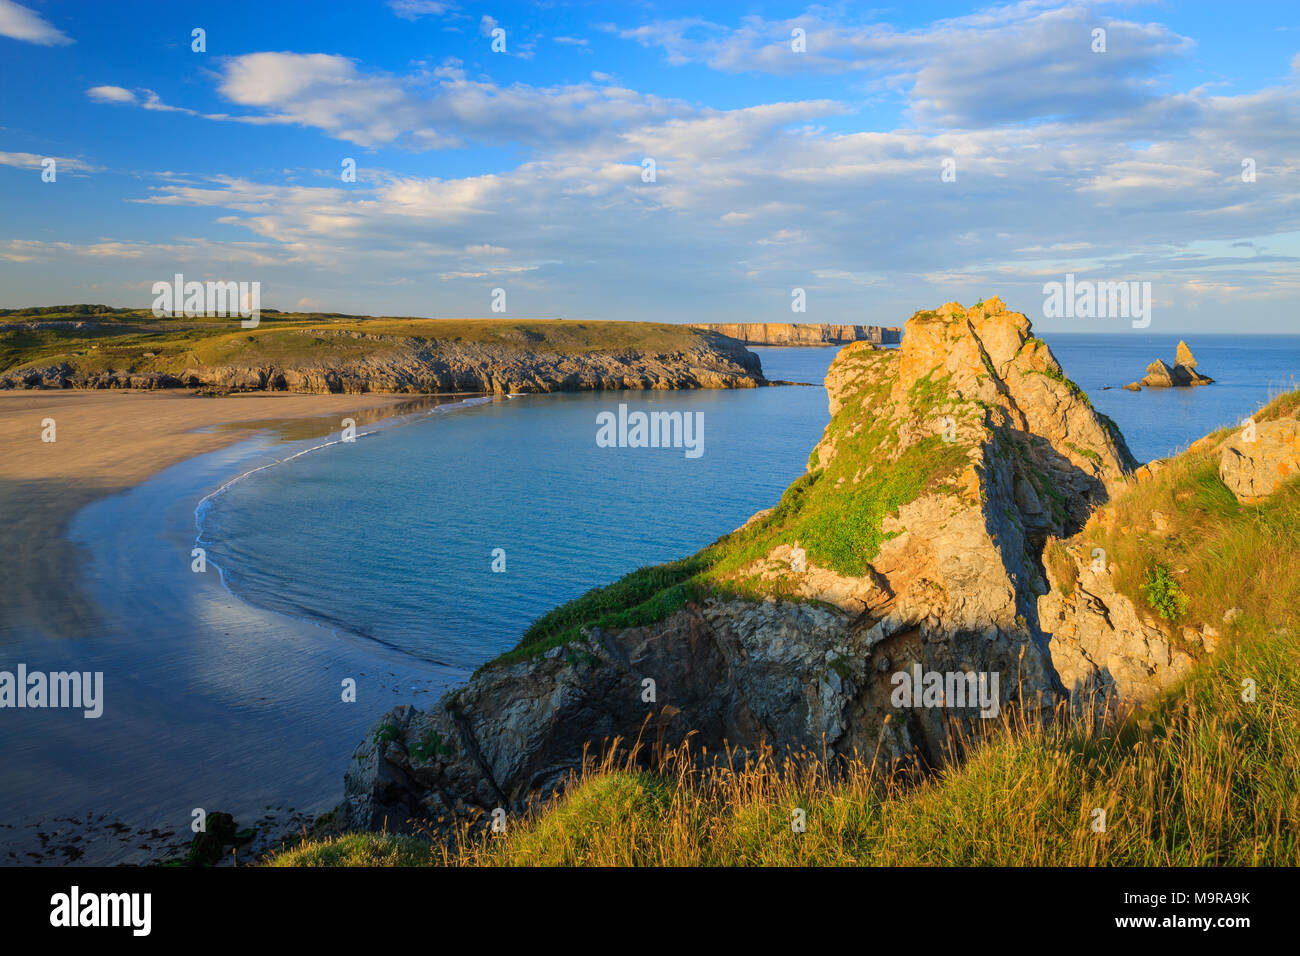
0, 0, 1300, 333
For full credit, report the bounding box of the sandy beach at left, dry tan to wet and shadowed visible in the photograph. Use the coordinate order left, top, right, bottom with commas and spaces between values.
0, 393, 467, 865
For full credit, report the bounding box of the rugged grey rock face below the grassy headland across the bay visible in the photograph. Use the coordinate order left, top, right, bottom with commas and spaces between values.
0, 328, 766, 394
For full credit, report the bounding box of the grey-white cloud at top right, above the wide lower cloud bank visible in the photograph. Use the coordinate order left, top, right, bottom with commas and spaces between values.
603, 3, 1192, 127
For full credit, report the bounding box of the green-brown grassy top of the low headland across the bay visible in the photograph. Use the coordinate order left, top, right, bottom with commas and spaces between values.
0, 306, 709, 375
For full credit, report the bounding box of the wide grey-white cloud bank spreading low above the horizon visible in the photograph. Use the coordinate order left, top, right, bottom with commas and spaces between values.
101, 55, 1300, 329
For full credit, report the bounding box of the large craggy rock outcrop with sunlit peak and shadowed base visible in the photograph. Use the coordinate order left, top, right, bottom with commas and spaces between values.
346, 298, 1134, 829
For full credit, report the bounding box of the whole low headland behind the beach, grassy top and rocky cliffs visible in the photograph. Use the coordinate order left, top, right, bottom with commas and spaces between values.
0, 313, 767, 394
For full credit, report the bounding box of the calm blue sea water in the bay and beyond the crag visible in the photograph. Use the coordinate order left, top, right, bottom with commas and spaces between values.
198, 333, 1300, 667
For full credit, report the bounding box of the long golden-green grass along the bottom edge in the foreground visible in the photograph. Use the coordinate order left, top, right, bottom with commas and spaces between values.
270, 619, 1300, 866
